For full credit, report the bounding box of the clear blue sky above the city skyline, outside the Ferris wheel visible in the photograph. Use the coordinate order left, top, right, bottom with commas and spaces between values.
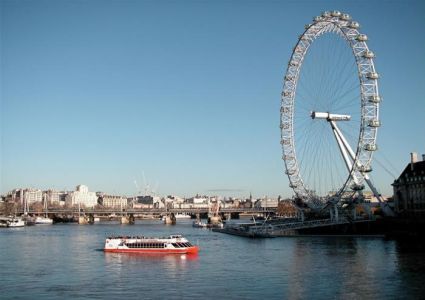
0, 0, 425, 197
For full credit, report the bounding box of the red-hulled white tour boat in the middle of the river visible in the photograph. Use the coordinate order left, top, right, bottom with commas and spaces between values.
104, 235, 198, 254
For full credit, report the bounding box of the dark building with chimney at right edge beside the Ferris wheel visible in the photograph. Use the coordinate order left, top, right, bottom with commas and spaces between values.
392, 153, 425, 216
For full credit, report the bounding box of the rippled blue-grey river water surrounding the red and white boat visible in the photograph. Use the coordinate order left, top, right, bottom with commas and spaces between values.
0, 220, 425, 299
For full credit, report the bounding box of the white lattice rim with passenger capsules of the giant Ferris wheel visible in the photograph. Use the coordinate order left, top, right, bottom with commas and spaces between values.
280, 11, 380, 207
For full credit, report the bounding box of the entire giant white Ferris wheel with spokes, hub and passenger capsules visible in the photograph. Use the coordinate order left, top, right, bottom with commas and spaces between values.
280, 11, 381, 209
